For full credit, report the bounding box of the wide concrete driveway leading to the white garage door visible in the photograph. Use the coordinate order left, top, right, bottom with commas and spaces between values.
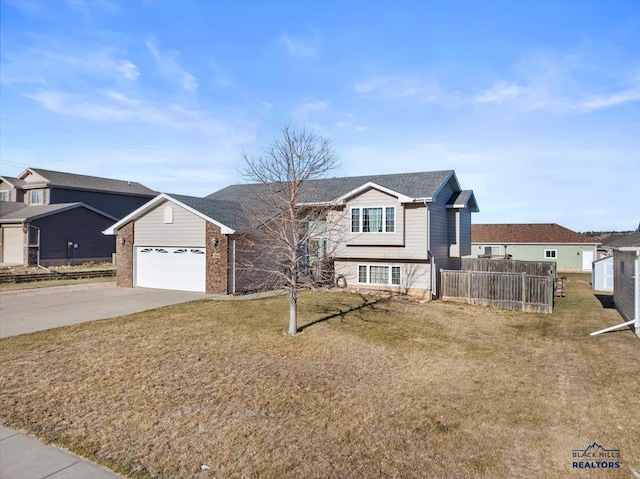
0, 283, 213, 338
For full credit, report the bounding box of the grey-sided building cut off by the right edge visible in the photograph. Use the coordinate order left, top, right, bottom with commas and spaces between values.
609, 232, 640, 337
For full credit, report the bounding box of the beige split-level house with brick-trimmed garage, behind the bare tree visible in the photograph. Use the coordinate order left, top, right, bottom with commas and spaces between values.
105, 170, 478, 295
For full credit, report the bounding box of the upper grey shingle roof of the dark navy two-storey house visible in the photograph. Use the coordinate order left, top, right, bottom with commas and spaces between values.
22, 168, 158, 197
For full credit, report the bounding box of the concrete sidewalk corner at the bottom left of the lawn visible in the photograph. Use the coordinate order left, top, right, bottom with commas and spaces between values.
0, 425, 121, 479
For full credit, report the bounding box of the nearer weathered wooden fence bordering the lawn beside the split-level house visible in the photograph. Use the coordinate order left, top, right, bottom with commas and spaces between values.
440, 270, 553, 313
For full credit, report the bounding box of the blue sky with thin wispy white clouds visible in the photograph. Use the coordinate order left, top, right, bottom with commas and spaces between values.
0, 0, 640, 231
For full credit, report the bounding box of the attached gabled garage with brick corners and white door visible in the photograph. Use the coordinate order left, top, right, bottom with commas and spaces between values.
105, 193, 243, 294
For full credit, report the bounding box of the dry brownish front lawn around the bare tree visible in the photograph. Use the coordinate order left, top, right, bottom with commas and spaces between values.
0, 283, 640, 478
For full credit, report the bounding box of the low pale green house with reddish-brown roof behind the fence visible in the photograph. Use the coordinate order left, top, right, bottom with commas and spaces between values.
470, 223, 598, 272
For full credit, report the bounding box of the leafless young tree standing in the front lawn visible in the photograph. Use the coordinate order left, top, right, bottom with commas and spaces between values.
242, 124, 338, 335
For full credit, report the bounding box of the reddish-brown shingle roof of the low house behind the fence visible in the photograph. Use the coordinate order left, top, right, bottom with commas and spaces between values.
471, 223, 598, 244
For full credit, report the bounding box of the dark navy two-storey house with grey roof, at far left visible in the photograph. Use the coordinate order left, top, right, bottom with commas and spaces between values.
0, 168, 157, 266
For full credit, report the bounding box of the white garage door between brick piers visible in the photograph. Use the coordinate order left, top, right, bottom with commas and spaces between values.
135, 247, 206, 292
